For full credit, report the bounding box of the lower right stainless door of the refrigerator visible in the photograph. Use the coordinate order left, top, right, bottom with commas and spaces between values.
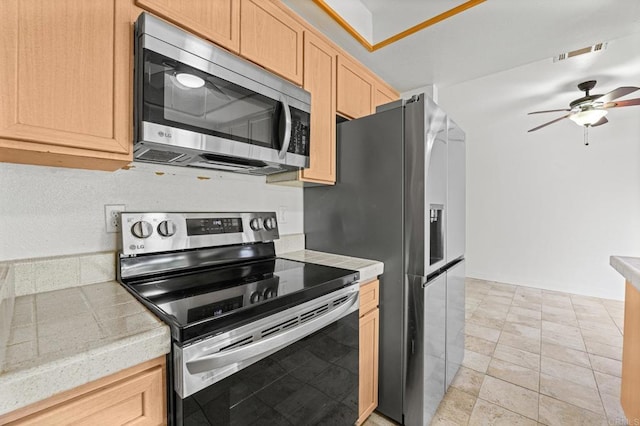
445, 260, 465, 391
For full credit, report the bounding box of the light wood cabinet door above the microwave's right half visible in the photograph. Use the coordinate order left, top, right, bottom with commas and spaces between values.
240, 0, 304, 86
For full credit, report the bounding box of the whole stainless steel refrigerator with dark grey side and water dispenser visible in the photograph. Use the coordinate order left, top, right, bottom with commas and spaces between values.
304, 95, 465, 426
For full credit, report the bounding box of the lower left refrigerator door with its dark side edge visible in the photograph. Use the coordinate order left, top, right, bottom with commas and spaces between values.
404, 273, 447, 426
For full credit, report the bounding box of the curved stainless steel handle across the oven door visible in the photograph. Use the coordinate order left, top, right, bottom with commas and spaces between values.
186, 292, 359, 374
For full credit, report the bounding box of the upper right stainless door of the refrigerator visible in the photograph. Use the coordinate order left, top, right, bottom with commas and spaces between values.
446, 119, 466, 263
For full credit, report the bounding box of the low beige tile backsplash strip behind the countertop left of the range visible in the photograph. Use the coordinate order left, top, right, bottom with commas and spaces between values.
12, 252, 116, 296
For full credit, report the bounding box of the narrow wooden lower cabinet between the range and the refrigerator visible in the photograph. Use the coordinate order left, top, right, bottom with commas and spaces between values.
357, 280, 380, 424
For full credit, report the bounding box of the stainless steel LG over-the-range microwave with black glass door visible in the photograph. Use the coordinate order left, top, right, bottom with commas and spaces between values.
134, 13, 311, 175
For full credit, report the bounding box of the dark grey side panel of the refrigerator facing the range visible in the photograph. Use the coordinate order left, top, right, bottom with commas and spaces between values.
304, 107, 405, 423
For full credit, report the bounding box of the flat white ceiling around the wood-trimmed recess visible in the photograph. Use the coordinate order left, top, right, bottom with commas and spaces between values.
283, 0, 640, 92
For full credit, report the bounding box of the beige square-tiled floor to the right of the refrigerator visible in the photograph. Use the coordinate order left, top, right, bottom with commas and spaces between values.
365, 279, 627, 426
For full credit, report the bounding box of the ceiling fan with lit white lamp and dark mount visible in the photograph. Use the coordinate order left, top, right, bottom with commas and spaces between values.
529, 80, 640, 132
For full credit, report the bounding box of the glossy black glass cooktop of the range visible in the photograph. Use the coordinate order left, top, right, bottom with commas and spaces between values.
123, 258, 358, 345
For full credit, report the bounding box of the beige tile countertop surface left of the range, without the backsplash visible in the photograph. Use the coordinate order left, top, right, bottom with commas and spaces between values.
0, 281, 171, 415
